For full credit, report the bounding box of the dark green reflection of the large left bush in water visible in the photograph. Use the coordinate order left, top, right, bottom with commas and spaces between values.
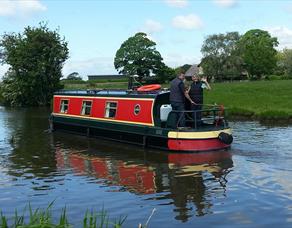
3, 108, 56, 179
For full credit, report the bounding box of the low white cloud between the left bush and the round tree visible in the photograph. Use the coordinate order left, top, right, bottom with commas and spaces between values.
63, 57, 118, 80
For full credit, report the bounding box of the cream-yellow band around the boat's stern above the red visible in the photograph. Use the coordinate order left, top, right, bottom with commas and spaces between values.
168, 128, 231, 139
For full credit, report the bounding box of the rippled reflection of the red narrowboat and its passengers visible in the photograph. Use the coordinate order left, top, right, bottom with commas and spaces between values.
54, 134, 233, 221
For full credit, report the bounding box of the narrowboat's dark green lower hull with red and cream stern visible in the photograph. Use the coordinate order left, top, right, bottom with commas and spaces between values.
51, 115, 231, 152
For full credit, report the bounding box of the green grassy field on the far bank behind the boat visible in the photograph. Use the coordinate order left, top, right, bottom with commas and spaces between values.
65, 80, 292, 120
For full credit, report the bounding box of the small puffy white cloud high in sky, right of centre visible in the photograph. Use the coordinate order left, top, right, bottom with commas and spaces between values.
172, 14, 203, 30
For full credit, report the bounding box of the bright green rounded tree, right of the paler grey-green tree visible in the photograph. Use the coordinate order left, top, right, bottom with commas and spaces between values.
239, 29, 278, 79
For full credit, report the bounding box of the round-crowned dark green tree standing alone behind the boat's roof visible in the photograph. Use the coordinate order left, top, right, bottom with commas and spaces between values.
114, 32, 163, 81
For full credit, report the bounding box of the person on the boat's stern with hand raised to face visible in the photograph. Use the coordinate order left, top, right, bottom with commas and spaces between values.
188, 74, 211, 127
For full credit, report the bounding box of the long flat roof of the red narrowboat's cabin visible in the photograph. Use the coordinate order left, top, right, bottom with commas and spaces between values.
54, 89, 169, 98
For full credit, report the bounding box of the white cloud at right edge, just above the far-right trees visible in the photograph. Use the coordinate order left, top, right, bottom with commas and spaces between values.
267, 26, 292, 50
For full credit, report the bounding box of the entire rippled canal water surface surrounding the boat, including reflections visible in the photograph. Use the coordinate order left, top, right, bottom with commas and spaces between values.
0, 107, 292, 227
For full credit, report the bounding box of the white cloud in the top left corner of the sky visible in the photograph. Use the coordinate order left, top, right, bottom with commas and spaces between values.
0, 0, 47, 17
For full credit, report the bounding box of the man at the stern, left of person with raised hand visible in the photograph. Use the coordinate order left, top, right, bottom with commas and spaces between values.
169, 71, 194, 127
